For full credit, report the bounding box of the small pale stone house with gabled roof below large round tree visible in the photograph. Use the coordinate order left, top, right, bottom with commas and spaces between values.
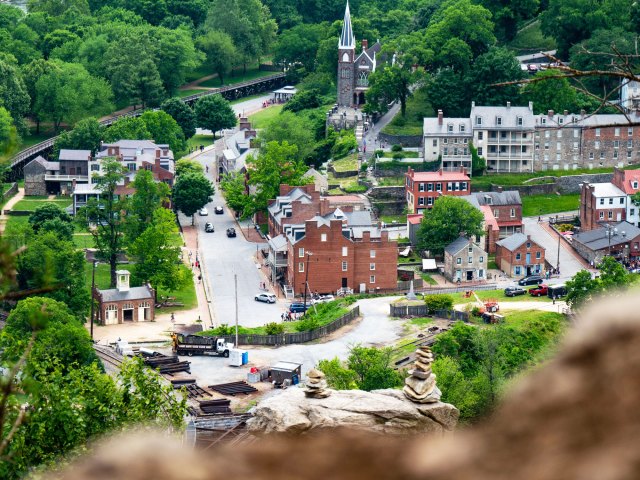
444, 237, 488, 282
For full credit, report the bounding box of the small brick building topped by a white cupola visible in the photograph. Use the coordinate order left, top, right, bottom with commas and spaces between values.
93, 270, 155, 325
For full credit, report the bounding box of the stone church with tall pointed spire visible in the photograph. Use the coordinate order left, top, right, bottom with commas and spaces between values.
338, 2, 380, 107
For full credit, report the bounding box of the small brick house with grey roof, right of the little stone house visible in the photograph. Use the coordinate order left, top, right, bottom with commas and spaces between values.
496, 233, 545, 278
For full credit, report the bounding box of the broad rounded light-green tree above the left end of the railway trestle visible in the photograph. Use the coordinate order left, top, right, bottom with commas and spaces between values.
34, 63, 113, 130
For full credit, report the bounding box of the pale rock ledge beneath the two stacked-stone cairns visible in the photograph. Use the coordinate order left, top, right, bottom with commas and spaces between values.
247, 387, 459, 435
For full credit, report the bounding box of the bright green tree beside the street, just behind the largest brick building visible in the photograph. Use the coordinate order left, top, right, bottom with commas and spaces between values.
246, 141, 307, 211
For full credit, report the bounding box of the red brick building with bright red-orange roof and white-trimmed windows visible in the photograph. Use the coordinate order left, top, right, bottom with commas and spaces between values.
405, 167, 471, 213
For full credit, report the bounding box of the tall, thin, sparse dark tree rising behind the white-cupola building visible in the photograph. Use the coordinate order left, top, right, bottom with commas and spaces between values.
78, 157, 127, 288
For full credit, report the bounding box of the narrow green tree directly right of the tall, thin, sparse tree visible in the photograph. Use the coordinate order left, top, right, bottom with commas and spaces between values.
126, 170, 170, 243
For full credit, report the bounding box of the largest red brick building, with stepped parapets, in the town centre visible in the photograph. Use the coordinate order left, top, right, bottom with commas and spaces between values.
285, 209, 398, 295
